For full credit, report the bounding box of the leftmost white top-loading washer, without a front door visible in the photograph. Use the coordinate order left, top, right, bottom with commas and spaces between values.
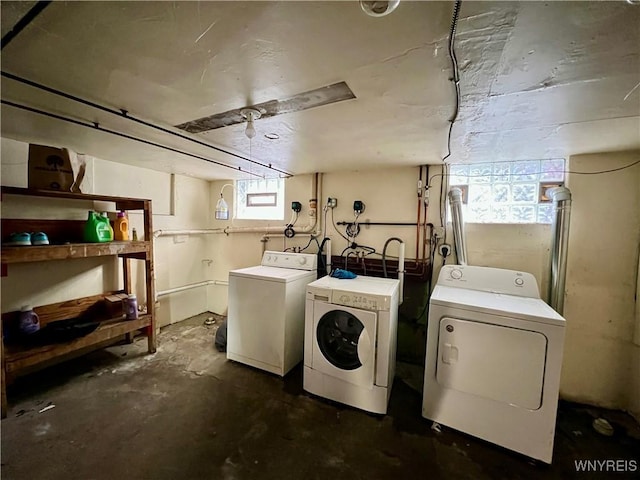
227, 251, 317, 376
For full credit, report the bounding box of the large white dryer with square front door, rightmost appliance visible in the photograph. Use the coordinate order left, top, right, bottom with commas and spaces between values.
422, 265, 565, 463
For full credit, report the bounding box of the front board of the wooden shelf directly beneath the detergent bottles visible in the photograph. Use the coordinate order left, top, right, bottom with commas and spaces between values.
1, 241, 150, 264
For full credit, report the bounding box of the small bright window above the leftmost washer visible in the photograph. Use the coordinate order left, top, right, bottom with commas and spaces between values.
235, 178, 284, 220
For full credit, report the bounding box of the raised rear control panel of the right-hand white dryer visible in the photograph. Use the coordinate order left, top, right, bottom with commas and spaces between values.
438, 265, 540, 298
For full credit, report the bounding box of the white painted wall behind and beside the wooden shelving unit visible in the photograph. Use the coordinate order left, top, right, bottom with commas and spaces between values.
1, 138, 212, 326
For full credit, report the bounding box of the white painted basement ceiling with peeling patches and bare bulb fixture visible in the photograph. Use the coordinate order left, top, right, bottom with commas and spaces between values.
0, 0, 640, 180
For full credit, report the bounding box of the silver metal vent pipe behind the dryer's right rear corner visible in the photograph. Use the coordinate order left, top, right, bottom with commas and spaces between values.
546, 187, 571, 315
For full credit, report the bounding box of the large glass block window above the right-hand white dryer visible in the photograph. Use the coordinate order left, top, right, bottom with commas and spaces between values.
449, 158, 565, 223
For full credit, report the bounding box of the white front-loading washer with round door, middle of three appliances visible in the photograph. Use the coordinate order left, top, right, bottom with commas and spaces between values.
303, 276, 400, 414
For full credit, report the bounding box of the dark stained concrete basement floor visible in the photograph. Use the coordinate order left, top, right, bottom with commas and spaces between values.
2, 315, 640, 480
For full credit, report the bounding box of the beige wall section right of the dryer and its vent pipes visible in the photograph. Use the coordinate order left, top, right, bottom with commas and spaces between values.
561, 152, 640, 416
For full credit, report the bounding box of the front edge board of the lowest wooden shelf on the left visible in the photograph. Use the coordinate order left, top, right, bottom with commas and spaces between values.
4, 315, 151, 372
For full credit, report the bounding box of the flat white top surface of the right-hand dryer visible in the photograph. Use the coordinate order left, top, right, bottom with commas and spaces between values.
430, 285, 565, 327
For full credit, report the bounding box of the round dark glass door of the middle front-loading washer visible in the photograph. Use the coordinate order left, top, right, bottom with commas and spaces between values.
316, 310, 372, 370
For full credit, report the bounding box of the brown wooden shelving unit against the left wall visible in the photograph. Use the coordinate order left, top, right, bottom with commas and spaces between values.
0, 187, 156, 417
